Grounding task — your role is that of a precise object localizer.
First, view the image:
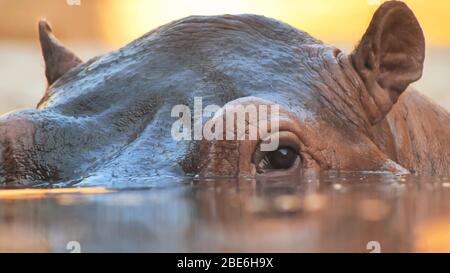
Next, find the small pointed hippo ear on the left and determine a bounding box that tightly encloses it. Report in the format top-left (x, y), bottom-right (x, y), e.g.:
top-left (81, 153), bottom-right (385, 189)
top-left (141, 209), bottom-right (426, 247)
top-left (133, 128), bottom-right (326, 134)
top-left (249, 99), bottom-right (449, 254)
top-left (39, 21), bottom-right (82, 85)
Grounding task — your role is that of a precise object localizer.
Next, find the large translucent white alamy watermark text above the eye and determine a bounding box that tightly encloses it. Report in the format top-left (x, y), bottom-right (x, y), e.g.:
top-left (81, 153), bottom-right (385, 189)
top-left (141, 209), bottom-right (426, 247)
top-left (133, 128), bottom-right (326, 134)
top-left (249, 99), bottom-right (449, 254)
top-left (171, 97), bottom-right (280, 151)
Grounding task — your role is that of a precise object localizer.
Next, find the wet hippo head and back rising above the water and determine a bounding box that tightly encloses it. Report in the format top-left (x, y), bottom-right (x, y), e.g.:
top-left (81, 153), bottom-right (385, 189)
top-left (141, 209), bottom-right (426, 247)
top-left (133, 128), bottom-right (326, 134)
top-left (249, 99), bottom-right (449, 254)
top-left (0, 1), bottom-right (450, 187)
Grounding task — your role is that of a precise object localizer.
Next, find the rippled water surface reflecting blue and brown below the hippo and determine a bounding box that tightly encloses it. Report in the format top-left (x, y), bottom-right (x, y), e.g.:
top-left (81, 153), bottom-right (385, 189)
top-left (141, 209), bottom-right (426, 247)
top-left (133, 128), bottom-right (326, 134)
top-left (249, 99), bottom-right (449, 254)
top-left (0, 173), bottom-right (450, 252)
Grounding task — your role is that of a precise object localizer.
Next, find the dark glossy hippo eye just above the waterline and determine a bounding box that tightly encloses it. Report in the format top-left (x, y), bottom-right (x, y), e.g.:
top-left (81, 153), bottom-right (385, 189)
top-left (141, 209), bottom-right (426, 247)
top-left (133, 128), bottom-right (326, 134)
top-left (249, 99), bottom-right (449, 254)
top-left (258, 147), bottom-right (301, 172)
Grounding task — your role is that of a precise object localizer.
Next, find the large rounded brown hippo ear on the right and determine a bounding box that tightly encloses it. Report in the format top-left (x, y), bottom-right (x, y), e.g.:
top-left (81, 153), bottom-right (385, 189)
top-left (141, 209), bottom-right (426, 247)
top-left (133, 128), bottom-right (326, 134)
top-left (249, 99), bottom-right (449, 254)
top-left (351, 1), bottom-right (425, 123)
